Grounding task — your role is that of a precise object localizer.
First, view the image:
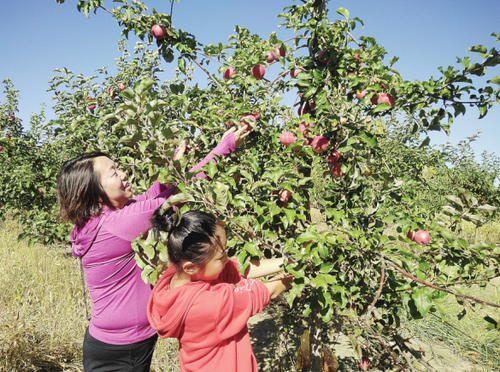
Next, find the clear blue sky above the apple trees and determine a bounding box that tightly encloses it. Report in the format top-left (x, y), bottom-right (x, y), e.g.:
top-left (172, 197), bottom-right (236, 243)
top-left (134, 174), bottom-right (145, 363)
top-left (0, 0), bottom-right (500, 160)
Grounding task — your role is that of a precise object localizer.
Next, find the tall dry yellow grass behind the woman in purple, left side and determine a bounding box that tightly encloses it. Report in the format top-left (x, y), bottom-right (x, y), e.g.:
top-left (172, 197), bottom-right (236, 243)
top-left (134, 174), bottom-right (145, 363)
top-left (0, 219), bottom-right (179, 372)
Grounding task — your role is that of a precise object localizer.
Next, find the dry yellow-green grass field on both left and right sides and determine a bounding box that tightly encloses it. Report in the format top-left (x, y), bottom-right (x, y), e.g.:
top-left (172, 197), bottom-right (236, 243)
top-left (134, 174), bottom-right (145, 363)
top-left (0, 220), bottom-right (500, 372)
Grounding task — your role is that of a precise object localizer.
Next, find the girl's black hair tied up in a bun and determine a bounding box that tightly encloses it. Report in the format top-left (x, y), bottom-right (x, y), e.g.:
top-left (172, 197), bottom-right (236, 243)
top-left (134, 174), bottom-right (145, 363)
top-left (151, 208), bottom-right (221, 269)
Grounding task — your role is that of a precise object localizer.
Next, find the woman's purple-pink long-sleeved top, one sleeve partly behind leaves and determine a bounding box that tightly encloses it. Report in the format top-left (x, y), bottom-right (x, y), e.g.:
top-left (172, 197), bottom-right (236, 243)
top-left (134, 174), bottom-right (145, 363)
top-left (71, 133), bottom-right (235, 345)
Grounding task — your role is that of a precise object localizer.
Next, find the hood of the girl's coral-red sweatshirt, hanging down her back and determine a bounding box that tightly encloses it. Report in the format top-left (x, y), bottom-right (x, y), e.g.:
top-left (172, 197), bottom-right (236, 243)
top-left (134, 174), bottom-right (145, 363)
top-left (147, 265), bottom-right (210, 338)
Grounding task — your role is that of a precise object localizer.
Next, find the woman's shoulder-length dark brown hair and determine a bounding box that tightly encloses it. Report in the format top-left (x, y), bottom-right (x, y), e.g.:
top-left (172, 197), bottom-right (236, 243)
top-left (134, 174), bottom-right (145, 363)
top-left (57, 152), bottom-right (111, 223)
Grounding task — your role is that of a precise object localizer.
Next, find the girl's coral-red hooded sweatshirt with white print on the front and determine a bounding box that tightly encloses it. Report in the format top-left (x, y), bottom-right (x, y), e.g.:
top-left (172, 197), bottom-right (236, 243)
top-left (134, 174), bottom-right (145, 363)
top-left (148, 260), bottom-right (270, 372)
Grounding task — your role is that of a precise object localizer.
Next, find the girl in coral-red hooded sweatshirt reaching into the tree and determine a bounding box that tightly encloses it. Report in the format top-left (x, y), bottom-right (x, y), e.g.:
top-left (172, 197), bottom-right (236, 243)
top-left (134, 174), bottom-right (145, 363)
top-left (148, 209), bottom-right (293, 372)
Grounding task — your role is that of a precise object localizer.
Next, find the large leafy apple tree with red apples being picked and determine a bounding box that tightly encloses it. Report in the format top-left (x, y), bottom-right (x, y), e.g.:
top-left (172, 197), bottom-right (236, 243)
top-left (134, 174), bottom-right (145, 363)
top-left (9, 0), bottom-right (500, 371)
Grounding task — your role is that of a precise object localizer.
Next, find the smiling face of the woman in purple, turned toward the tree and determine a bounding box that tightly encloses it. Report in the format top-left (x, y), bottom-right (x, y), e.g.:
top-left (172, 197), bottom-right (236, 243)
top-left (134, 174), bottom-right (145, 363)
top-left (94, 156), bottom-right (132, 209)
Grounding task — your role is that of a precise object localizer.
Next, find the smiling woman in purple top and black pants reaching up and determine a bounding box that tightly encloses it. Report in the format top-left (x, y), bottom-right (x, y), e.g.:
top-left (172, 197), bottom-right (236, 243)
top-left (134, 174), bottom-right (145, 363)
top-left (57, 126), bottom-right (249, 372)
